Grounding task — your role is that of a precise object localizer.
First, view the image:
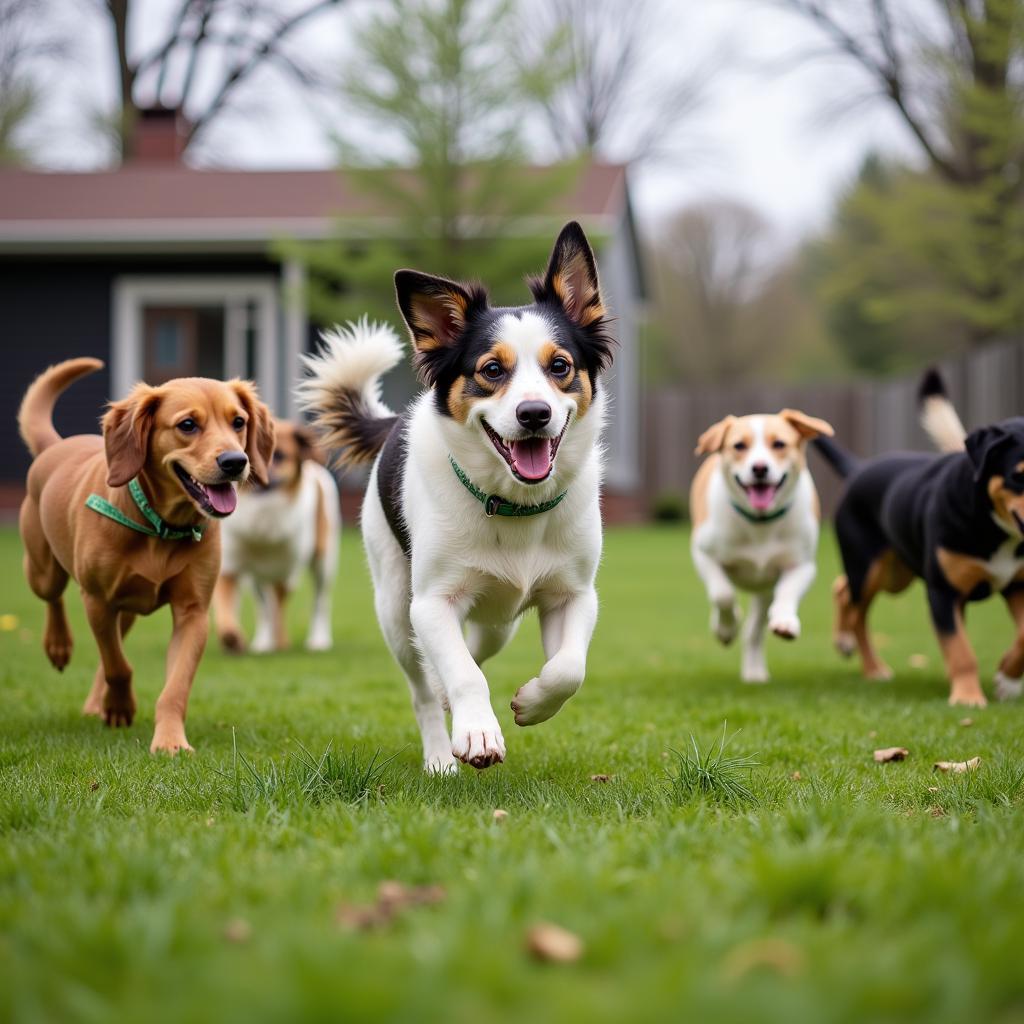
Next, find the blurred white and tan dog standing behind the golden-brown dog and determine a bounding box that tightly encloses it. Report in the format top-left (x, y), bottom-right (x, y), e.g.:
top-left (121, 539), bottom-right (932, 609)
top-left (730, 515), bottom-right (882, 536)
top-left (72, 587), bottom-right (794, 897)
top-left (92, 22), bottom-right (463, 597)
top-left (213, 420), bottom-right (341, 652)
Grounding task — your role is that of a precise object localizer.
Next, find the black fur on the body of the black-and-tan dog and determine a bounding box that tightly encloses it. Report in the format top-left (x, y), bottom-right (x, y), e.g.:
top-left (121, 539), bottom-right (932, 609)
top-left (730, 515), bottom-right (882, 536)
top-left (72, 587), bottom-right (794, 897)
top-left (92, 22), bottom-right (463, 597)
top-left (815, 419), bottom-right (1024, 634)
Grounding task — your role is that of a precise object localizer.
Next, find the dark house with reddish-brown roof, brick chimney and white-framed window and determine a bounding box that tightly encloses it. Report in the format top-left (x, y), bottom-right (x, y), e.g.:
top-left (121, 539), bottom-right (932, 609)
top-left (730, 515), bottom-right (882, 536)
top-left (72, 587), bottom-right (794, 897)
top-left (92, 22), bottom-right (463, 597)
top-left (0, 112), bottom-right (644, 518)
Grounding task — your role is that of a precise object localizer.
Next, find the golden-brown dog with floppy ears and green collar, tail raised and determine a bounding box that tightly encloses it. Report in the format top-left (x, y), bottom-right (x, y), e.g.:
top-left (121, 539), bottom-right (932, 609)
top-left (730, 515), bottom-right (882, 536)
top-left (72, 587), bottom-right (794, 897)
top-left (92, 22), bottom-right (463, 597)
top-left (18, 358), bottom-right (273, 754)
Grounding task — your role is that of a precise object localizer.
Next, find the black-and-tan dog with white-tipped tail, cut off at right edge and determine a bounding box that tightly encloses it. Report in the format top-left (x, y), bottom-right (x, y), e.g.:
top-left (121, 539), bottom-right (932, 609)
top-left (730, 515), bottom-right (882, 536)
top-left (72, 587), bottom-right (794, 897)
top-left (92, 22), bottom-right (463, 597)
top-left (813, 373), bottom-right (1024, 707)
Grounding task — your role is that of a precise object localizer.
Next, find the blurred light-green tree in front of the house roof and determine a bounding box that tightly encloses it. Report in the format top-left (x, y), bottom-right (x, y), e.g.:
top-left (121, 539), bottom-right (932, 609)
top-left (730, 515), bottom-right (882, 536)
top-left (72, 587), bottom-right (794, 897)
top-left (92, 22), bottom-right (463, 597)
top-left (285, 0), bottom-right (579, 323)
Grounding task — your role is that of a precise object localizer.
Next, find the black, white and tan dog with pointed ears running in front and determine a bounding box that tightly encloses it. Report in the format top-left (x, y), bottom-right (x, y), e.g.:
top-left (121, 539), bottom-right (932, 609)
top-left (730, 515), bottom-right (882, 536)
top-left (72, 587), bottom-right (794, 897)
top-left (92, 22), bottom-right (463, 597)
top-left (300, 223), bottom-right (613, 772)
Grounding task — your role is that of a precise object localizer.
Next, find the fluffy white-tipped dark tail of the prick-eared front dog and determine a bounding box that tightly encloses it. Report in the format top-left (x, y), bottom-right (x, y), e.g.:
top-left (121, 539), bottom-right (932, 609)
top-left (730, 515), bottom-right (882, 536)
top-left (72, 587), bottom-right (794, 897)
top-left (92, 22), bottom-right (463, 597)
top-left (297, 316), bottom-right (402, 465)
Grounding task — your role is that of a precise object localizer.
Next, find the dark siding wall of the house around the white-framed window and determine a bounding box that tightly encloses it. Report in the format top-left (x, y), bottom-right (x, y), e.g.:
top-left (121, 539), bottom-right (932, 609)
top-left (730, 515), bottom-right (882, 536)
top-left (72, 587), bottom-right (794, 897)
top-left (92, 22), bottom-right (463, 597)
top-left (0, 256), bottom-right (279, 487)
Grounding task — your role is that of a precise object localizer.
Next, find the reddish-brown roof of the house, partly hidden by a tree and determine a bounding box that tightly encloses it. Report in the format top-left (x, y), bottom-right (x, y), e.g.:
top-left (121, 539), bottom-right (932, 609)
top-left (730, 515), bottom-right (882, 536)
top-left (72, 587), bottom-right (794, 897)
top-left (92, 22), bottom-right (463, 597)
top-left (0, 164), bottom-right (626, 250)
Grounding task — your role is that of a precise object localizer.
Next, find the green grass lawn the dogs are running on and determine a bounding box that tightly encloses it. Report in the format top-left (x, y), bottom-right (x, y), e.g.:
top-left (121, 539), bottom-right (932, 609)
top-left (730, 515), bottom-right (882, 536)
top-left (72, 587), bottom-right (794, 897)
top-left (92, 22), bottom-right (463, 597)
top-left (0, 528), bottom-right (1024, 1024)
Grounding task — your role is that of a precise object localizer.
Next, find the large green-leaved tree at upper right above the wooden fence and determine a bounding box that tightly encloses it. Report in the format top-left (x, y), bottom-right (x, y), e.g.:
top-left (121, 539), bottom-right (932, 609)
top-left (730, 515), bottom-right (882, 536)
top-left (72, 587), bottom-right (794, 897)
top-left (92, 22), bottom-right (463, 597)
top-left (765, 0), bottom-right (1024, 350)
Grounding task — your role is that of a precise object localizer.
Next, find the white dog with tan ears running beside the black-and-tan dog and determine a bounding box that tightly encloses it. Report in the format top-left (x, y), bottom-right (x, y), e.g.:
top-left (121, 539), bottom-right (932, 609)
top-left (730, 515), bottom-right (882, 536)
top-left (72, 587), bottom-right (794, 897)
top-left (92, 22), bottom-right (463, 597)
top-left (690, 409), bottom-right (833, 683)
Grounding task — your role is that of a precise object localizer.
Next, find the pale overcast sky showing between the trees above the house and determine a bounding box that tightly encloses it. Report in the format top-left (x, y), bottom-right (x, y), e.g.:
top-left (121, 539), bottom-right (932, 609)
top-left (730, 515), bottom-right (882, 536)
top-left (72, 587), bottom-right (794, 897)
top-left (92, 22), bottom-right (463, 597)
top-left (36, 0), bottom-right (915, 242)
